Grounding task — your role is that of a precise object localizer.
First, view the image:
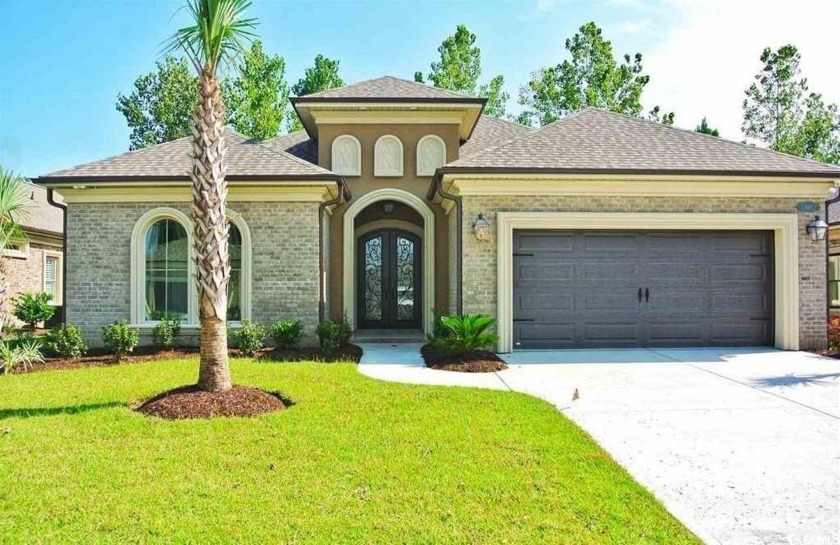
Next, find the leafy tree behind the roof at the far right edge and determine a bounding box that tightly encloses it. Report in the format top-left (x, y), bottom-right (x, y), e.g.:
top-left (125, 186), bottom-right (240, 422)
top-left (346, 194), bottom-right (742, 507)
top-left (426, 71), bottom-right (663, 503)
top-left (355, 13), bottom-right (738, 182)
top-left (741, 44), bottom-right (840, 163)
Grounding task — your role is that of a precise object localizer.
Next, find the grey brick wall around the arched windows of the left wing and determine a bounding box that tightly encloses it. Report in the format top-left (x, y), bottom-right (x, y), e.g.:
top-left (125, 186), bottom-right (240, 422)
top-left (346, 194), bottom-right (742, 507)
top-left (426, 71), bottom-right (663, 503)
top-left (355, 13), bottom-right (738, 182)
top-left (65, 202), bottom-right (319, 346)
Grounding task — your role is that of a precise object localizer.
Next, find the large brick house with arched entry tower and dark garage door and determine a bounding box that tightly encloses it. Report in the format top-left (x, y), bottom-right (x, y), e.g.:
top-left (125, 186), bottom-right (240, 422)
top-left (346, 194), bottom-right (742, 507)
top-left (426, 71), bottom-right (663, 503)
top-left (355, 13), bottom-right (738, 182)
top-left (38, 77), bottom-right (840, 352)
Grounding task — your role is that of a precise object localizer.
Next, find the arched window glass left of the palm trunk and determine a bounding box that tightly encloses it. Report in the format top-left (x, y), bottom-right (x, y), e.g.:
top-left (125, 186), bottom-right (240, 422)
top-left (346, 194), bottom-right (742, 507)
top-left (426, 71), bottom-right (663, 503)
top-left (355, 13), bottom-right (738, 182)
top-left (145, 219), bottom-right (190, 321)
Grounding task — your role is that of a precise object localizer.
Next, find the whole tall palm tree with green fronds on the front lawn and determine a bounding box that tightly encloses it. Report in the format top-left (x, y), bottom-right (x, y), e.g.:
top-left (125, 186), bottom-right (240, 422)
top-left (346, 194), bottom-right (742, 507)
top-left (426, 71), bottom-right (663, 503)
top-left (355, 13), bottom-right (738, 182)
top-left (166, 0), bottom-right (256, 392)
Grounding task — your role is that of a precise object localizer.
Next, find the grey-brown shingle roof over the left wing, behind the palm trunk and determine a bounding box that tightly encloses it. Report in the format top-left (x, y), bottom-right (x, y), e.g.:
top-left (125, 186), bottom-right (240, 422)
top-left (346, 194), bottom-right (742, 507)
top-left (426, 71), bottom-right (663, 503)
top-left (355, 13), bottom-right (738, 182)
top-left (39, 128), bottom-right (338, 182)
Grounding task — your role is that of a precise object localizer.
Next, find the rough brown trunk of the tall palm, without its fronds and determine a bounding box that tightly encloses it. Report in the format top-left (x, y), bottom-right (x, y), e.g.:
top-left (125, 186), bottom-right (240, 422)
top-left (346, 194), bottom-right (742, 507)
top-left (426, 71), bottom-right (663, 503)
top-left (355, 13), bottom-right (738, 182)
top-left (190, 70), bottom-right (231, 392)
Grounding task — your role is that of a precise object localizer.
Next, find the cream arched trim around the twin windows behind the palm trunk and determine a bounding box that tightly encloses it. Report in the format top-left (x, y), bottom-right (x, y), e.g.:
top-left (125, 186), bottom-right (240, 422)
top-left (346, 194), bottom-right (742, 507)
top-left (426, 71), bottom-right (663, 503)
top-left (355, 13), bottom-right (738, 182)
top-left (130, 207), bottom-right (251, 328)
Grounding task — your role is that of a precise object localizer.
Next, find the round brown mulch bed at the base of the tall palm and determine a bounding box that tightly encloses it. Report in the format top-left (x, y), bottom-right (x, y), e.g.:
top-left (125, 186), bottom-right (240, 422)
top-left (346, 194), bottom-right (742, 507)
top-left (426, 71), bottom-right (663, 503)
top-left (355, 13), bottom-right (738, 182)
top-left (137, 385), bottom-right (291, 420)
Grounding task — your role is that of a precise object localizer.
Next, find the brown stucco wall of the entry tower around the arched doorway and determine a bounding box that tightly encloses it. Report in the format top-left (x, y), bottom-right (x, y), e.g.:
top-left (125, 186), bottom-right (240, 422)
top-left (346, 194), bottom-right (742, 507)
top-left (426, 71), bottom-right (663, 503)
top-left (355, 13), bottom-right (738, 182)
top-left (318, 124), bottom-right (459, 321)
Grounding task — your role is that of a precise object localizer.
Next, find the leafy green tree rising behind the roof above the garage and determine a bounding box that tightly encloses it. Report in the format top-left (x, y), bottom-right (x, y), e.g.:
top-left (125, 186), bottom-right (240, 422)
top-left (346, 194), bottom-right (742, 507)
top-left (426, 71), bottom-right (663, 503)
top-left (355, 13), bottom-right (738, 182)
top-left (519, 22), bottom-right (673, 125)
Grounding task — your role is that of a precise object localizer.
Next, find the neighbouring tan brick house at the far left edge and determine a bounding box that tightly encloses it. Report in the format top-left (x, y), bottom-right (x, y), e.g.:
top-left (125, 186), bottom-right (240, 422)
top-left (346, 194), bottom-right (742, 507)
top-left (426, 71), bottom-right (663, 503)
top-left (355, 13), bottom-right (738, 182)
top-left (2, 182), bottom-right (64, 325)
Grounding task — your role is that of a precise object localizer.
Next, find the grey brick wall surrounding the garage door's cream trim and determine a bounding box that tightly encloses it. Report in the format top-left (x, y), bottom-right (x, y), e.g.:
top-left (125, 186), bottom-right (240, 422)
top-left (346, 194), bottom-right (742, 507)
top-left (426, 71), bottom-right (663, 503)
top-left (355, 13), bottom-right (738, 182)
top-left (461, 196), bottom-right (827, 350)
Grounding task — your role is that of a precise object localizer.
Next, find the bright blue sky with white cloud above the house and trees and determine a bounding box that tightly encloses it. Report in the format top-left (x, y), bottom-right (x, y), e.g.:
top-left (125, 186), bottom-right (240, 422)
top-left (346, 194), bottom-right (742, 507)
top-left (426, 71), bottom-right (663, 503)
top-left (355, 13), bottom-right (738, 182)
top-left (0, 0), bottom-right (840, 177)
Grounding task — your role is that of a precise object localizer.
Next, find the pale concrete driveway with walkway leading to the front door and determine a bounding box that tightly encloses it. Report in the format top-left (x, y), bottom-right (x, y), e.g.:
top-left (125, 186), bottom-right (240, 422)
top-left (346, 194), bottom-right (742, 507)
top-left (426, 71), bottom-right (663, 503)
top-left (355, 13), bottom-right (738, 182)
top-left (359, 345), bottom-right (840, 544)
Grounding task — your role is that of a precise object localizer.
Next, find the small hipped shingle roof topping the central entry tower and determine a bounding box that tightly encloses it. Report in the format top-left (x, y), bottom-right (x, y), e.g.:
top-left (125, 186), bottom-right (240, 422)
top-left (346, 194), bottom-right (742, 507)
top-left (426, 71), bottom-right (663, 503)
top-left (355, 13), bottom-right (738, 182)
top-left (292, 76), bottom-right (484, 102)
